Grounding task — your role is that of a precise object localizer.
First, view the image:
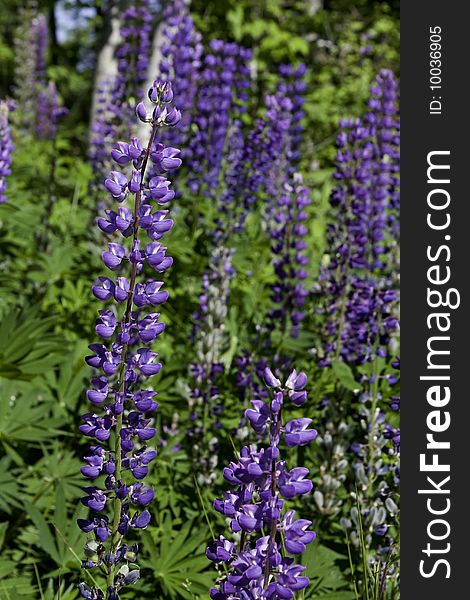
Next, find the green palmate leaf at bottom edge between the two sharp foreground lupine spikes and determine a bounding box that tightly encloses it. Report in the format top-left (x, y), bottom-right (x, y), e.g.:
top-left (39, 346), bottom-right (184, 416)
top-left (142, 519), bottom-right (213, 600)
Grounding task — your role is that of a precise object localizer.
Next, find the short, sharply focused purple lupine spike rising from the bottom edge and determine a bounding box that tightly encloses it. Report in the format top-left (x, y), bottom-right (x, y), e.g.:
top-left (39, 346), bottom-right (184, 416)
top-left (206, 368), bottom-right (317, 600)
